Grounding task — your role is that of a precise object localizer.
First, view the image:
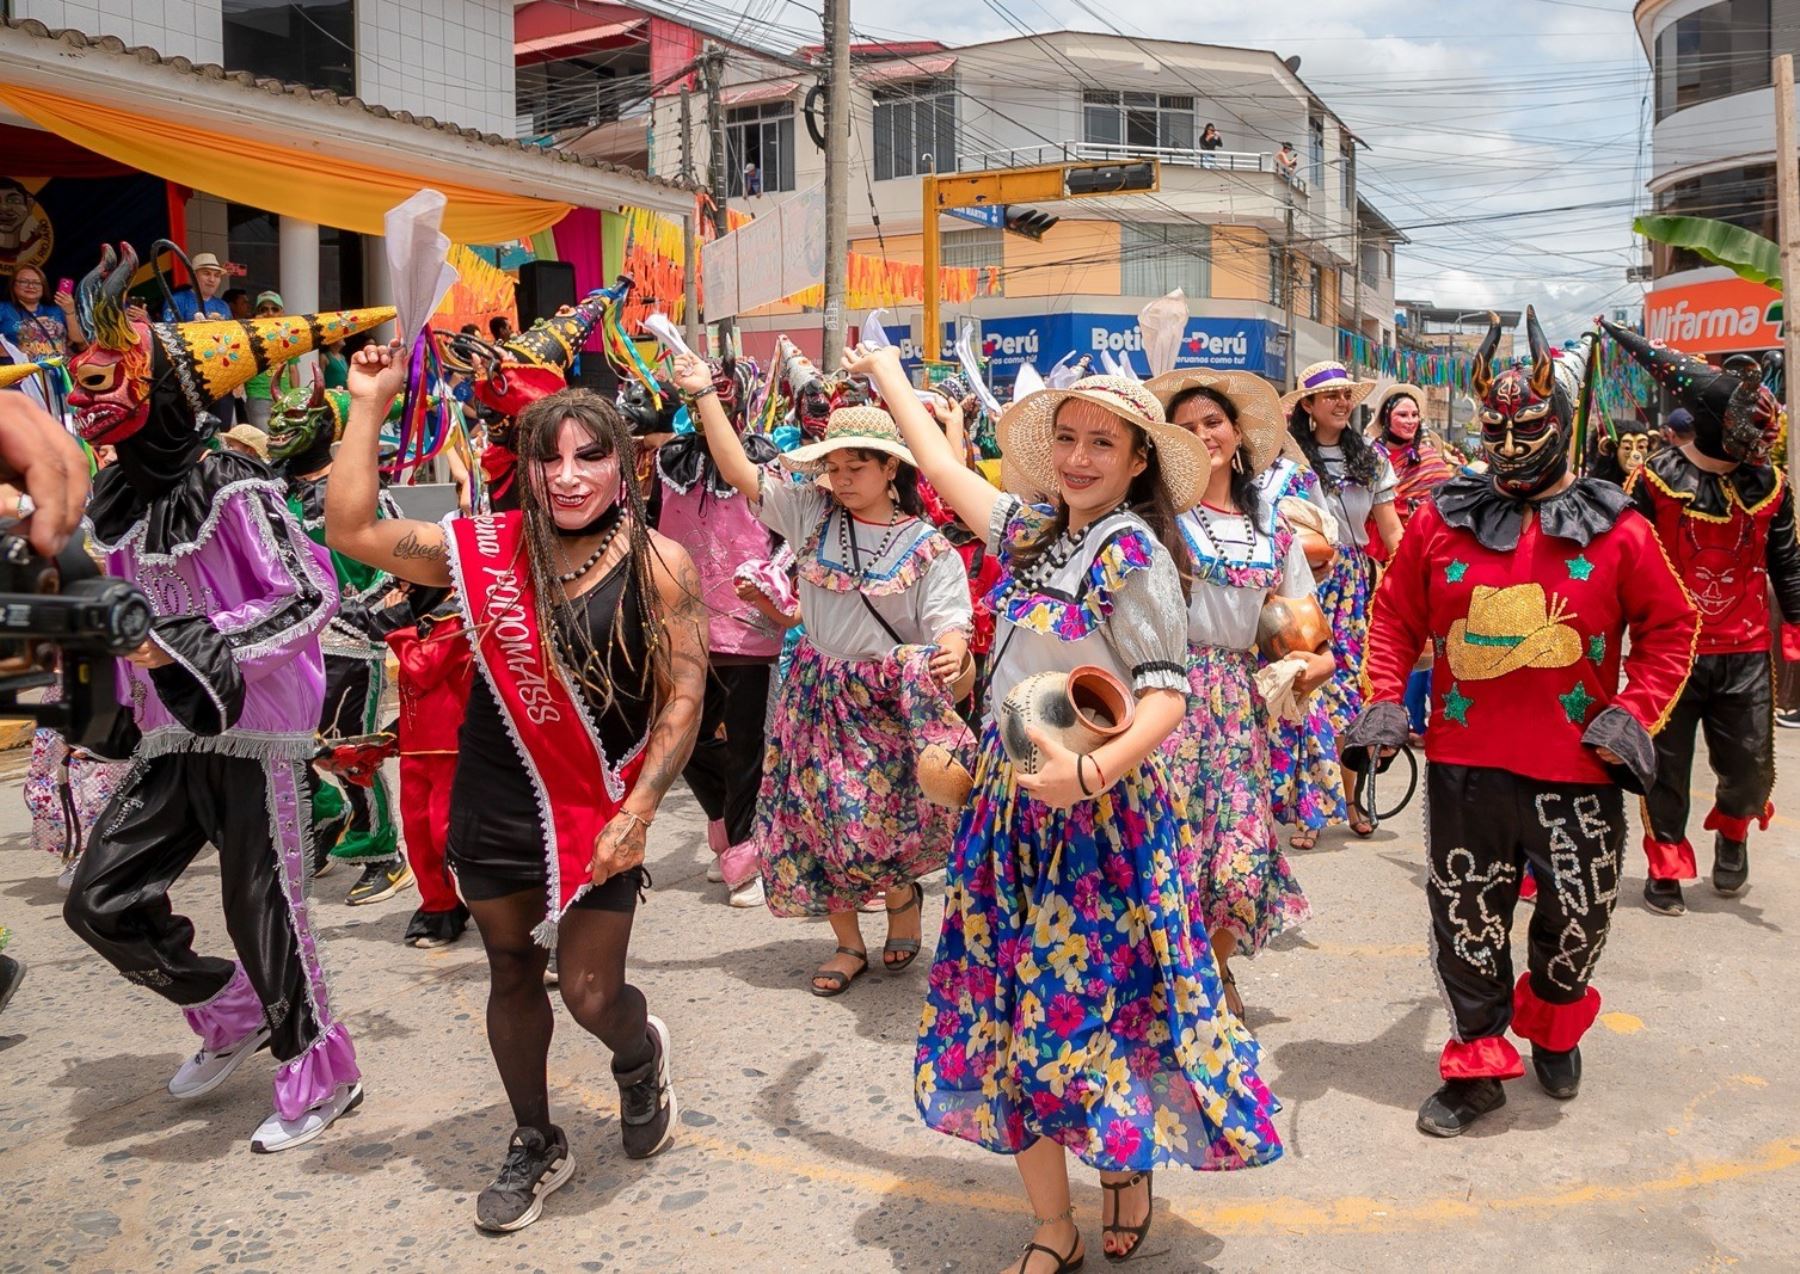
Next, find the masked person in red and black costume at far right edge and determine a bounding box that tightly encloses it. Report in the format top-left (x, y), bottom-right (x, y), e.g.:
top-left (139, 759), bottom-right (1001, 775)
top-left (1606, 324), bottom-right (1800, 914)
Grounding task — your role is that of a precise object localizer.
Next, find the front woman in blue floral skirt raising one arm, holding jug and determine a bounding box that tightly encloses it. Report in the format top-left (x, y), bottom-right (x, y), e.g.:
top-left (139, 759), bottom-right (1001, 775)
top-left (846, 347), bottom-right (1282, 1274)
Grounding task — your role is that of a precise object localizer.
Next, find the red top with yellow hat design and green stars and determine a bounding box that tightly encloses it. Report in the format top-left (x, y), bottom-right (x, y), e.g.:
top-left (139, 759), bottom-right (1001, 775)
top-left (1363, 502), bottom-right (1699, 785)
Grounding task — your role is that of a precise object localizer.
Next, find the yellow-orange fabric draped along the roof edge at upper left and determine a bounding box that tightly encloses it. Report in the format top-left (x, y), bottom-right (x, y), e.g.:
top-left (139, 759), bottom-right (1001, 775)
top-left (0, 85), bottom-right (572, 243)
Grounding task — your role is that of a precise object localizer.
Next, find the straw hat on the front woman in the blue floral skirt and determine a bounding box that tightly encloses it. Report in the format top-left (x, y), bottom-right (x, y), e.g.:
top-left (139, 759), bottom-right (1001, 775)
top-left (995, 376), bottom-right (1213, 513)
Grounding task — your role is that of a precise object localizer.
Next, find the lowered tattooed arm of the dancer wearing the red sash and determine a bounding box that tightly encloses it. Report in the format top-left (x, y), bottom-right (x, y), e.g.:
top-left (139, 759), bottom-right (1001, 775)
top-left (592, 531), bottom-right (707, 885)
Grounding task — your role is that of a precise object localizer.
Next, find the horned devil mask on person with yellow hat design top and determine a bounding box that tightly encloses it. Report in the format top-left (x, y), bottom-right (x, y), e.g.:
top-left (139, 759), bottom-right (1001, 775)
top-left (1472, 308), bottom-right (1573, 500)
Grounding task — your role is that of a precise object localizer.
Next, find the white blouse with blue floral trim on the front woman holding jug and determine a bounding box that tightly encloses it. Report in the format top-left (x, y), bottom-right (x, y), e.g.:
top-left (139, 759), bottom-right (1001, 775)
top-left (988, 493), bottom-right (1188, 711)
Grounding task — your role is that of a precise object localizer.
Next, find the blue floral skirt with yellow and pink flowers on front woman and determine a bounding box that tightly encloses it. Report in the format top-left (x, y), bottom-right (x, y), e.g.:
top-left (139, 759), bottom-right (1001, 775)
top-left (914, 725), bottom-right (1282, 1171)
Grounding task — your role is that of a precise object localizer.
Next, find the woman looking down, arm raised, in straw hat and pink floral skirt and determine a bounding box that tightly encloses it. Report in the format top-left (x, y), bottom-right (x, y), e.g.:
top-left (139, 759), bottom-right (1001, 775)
top-left (675, 356), bottom-right (974, 995)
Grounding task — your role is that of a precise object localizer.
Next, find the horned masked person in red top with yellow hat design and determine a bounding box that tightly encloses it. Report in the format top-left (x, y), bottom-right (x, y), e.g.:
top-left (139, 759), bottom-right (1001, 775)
top-left (1346, 315), bottom-right (1697, 1135)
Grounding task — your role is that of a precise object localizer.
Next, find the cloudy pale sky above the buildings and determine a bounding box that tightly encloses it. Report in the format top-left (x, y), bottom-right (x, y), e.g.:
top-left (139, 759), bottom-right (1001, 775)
top-left (795, 0), bottom-right (1651, 340)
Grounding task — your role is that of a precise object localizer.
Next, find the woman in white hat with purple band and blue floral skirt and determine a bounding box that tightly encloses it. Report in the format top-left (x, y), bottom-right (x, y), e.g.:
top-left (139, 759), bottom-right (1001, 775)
top-left (1282, 362), bottom-right (1400, 837)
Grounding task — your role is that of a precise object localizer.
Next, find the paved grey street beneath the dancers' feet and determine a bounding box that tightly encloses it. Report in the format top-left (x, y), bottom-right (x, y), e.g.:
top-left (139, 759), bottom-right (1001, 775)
top-left (0, 732), bottom-right (1800, 1274)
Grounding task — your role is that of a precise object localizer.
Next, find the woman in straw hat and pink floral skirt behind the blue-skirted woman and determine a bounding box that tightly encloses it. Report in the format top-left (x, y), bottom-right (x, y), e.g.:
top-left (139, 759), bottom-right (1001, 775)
top-left (1147, 371), bottom-right (1332, 1017)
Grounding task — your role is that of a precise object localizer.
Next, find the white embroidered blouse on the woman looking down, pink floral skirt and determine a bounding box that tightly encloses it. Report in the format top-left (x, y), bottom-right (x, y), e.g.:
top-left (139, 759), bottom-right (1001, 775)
top-left (756, 464), bottom-right (970, 660)
